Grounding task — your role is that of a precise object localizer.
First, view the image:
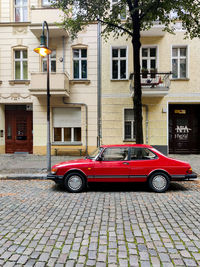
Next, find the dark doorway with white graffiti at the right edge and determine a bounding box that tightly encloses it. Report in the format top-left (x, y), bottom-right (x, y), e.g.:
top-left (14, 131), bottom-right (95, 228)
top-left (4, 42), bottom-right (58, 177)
top-left (169, 104), bottom-right (200, 154)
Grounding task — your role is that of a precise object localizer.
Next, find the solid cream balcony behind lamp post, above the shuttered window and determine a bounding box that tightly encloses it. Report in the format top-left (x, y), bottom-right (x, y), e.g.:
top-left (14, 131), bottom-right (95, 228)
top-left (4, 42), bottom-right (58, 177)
top-left (29, 72), bottom-right (70, 97)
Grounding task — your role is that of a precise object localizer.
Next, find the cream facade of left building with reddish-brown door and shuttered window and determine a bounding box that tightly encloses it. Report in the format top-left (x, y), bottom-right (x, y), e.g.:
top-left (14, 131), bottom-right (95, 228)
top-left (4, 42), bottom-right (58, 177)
top-left (0, 0), bottom-right (97, 154)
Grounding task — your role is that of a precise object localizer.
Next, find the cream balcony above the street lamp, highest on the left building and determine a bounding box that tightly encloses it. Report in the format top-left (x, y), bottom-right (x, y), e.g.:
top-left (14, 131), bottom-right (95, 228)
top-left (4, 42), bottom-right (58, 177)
top-left (30, 7), bottom-right (68, 38)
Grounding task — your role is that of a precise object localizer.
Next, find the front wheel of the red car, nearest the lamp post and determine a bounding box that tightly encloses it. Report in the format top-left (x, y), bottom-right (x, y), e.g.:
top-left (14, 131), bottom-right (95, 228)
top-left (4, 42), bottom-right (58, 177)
top-left (64, 172), bottom-right (86, 193)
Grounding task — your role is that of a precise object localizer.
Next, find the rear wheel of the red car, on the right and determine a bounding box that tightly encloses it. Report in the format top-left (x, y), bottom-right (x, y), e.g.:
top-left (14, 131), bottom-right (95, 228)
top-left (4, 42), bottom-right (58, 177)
top-left (148, 172), bottom-right (170, 193)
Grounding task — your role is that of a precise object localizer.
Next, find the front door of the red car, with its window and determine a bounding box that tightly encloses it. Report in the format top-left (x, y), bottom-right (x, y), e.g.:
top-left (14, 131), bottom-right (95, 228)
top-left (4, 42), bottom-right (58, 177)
top-left (94, 147), bottom-right (130, 182)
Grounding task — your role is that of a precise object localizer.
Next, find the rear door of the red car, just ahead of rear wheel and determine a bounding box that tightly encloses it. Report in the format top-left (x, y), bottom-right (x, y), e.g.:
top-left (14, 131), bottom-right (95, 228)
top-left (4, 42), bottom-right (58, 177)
top-left (129, 147), bottom-right (158, 182)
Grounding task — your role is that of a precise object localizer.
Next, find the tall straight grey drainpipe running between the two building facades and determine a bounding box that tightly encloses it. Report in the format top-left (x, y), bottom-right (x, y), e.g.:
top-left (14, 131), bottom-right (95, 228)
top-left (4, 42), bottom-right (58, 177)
top-left (97, 20), bottom-right (102, 147)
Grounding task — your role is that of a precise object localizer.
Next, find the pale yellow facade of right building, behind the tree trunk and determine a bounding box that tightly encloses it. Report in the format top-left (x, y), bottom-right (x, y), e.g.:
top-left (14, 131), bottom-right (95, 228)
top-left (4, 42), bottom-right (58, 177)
top-left (102, 21), bottom-right (200, 154)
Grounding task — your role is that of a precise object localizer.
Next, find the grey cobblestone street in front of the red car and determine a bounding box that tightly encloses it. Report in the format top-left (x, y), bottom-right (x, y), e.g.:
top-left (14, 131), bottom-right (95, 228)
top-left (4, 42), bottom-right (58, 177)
top-left (0, 180), bottom-right (200, 267)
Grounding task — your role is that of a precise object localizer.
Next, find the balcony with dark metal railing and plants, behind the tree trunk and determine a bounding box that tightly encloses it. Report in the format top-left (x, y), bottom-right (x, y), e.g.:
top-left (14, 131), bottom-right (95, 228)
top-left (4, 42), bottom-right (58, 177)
top-left (130, 72), bottom-right (172, 97)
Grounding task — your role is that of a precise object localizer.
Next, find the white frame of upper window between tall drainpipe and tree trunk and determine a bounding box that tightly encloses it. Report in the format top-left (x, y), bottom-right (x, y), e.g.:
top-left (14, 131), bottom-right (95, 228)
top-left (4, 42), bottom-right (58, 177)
top-left (111, 46), bottom-right (128, 81)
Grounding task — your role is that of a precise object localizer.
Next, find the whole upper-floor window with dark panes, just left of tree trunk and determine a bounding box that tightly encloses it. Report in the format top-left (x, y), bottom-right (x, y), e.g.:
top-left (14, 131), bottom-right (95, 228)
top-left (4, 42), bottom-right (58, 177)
top-left (112, 48), bottom-right (127, 80)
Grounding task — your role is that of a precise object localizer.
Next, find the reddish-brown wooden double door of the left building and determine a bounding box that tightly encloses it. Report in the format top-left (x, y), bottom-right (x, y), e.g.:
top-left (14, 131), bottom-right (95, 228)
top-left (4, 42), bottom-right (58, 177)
top-left (5, 105), bottom-right (33, 154)
